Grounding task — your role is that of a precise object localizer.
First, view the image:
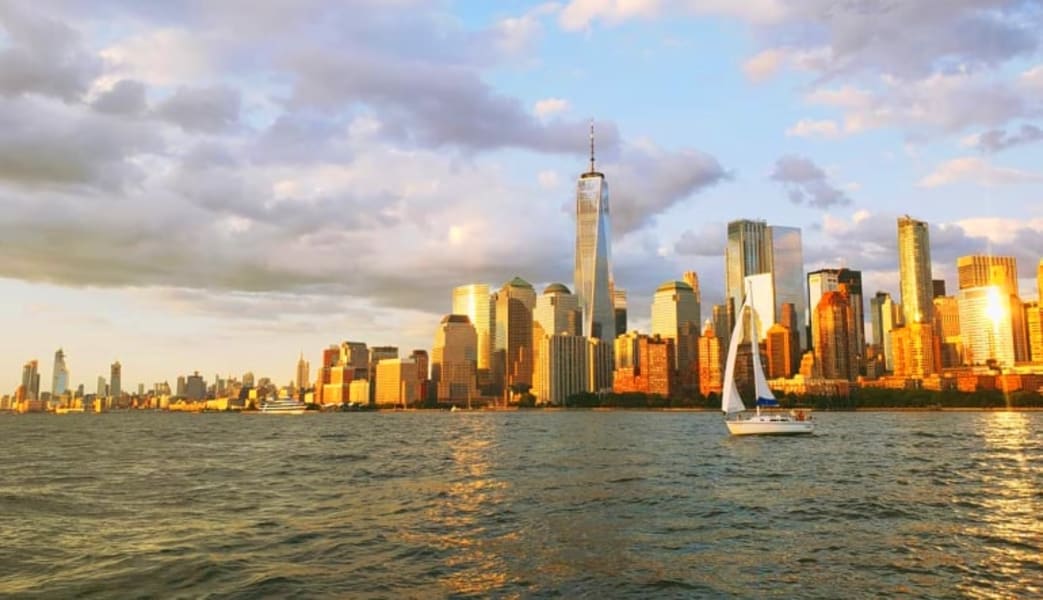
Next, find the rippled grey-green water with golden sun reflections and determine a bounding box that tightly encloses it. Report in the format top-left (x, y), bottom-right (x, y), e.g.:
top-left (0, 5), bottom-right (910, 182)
top-left (0, 411), bottom-right (1043, 598)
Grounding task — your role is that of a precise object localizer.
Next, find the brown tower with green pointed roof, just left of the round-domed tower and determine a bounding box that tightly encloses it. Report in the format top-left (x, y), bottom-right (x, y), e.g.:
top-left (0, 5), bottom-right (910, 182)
top-left (493, 278), bottom-right (534, 389)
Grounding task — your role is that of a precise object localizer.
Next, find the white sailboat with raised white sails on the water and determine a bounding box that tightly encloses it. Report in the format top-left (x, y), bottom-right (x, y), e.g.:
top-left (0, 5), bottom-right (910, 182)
top-left (721, 284), bottom-right (815, 435)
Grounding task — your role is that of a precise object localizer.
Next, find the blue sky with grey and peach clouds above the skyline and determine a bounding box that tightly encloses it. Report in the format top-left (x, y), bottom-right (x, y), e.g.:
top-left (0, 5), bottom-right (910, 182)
top-left (0, 0), bottom-right (1043, 393)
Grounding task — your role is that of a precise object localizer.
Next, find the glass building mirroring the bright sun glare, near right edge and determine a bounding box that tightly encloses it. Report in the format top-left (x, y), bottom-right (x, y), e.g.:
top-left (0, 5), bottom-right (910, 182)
top-left (959, 285), bottom-right (1015, 367)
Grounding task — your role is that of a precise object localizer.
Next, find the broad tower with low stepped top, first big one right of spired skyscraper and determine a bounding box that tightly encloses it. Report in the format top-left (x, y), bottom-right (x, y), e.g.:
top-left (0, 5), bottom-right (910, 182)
top-left (652, 282), bottom-right (700, 386)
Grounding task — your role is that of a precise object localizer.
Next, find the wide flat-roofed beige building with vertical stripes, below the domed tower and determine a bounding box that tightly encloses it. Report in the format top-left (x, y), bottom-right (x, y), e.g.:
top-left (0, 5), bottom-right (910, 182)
top-left (532, 327), bottom-right (602, 406)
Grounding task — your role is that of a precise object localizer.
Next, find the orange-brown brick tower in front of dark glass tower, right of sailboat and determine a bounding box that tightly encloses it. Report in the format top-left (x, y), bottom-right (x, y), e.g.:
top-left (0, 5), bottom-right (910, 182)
top-left (812, 284), bottom-right (858, 381)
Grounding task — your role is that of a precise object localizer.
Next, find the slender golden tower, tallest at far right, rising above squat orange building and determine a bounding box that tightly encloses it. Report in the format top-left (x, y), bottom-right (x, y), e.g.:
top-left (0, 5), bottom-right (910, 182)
top-left (898, 215), bottom-right (933, 326)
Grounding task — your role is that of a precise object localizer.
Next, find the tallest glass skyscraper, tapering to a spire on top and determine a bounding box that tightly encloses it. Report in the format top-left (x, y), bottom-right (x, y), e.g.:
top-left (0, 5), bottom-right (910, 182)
top-left (574, 121), bottom-right (615, 341)
